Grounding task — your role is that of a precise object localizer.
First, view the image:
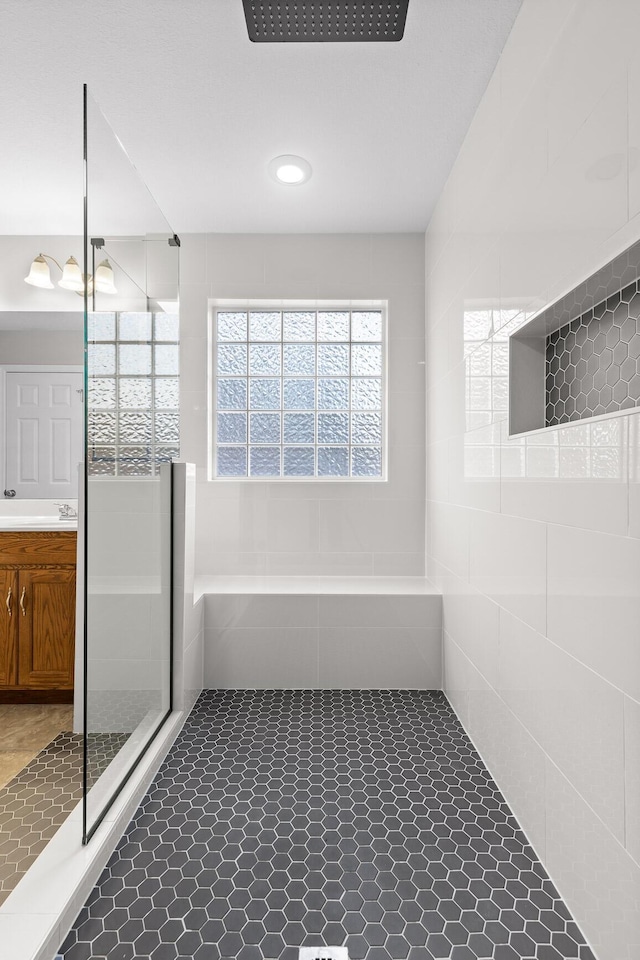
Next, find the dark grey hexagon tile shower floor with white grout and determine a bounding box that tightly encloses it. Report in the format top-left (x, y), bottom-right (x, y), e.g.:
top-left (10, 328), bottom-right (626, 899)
top-left (61, 690), bottom-right (593, 960)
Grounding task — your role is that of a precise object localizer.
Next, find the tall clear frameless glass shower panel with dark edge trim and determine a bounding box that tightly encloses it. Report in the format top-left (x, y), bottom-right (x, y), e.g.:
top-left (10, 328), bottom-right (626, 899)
top-left (82, 89), bottom-right (180, 841)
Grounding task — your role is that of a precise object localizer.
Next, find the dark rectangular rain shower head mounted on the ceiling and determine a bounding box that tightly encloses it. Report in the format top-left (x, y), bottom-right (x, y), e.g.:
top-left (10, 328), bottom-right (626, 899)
top-left (242, 0), bottom-right (409, 43)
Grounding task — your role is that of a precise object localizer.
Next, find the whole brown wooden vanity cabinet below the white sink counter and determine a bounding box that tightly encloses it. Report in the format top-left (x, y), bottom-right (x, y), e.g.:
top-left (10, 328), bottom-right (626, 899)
top-left (0, 531), bottom-right (76, 703)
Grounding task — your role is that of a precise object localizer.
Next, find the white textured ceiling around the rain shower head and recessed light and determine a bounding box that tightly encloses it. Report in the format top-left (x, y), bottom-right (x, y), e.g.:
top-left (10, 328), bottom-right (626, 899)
top-left (0, 0), bottom-right (521, 234)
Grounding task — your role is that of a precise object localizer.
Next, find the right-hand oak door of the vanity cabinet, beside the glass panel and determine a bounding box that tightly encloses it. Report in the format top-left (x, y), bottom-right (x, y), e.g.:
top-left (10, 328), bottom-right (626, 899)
top-left (17, 567), bottom-right (76, 690)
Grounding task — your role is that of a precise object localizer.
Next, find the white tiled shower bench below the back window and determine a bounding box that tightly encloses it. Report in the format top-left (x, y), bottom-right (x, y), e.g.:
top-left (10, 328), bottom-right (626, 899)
top-left (194, 576), bottom-right (442, 690)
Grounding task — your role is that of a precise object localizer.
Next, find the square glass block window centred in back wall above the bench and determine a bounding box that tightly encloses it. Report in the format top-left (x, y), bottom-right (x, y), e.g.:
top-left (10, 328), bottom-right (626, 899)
top-left (213, 307), bottom-right (385, 480)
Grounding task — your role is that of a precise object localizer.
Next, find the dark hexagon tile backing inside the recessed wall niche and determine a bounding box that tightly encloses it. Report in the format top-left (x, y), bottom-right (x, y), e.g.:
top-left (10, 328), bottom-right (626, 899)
top-left (545, 281), bottom-right (640, 427)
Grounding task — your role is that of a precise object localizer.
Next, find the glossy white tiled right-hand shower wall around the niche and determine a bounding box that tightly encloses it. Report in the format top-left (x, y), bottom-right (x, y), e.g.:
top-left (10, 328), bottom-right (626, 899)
top-left (425, 0), bottom-right (640, 960)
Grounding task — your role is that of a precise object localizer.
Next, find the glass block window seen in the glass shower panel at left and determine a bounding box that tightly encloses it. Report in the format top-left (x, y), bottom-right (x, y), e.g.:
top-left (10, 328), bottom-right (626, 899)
top-left (87, 313), bottom-right (180, 477)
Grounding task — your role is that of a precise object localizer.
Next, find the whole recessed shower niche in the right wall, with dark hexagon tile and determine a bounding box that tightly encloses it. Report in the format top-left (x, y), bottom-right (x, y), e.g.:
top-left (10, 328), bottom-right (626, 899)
top-left (509, 241), bottom-right (640, 436)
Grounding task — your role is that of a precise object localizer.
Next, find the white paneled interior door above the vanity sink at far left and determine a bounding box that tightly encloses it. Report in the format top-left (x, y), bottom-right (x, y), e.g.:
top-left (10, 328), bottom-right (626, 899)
top-left (5, 371), bottom-right (83, 500)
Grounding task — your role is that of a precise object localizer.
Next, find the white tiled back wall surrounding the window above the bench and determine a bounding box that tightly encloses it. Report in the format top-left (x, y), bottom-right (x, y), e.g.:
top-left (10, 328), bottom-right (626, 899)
top-left (180, 234), bottom-right (425, 576)
